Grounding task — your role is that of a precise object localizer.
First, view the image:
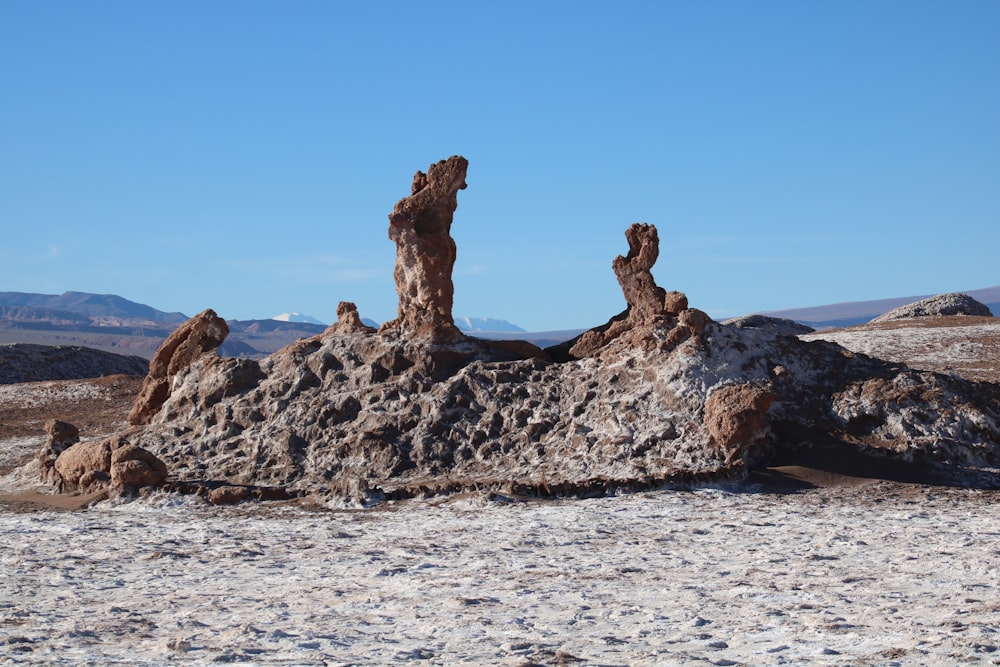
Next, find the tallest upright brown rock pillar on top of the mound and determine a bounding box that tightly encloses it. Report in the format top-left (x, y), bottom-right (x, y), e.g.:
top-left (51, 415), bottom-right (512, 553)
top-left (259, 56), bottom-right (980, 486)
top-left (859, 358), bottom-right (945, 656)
top-left (379, 155), bottom-right (469, 342)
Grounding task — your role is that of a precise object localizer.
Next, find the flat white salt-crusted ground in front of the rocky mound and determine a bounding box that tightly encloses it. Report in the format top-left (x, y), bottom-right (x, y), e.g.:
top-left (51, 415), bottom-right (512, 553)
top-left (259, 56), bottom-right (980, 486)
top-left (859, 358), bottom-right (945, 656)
top-left (0, 481), bottom-right (1000, 665)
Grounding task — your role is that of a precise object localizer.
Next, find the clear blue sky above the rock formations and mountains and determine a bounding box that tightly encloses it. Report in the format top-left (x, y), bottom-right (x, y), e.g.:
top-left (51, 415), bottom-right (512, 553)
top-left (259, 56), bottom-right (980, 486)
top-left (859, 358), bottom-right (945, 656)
top-left (0, 0), bottom-right (1000, 330)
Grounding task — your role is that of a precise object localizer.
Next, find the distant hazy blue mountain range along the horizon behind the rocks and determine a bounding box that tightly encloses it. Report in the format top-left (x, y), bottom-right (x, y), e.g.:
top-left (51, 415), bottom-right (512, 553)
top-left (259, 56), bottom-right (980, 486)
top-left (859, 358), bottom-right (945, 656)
top-left (0, 286), bottom-right (1000, 359)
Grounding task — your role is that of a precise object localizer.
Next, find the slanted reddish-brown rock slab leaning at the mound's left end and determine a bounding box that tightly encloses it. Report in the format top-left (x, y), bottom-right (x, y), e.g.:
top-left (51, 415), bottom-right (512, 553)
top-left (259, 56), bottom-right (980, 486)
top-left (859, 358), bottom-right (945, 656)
top-left (128, 308), bottom-right (229, 426)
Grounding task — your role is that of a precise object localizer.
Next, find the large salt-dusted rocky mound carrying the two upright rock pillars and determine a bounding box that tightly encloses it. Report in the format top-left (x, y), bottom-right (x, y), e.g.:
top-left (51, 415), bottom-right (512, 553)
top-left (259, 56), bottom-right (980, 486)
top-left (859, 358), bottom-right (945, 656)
top-left (41, 157), bottom-right (1000, 499)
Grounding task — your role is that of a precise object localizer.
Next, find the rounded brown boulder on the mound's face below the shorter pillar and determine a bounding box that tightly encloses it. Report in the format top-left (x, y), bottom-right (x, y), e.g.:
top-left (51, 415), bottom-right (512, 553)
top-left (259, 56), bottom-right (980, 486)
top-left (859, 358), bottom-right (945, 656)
top-left (705, 384), bottom-right (774, 464)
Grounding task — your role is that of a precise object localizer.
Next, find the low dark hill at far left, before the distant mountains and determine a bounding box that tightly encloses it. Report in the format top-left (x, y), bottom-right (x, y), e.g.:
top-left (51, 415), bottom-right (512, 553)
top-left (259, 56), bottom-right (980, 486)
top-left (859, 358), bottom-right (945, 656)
top-left (0, 343), bottom-right (149, 384)
